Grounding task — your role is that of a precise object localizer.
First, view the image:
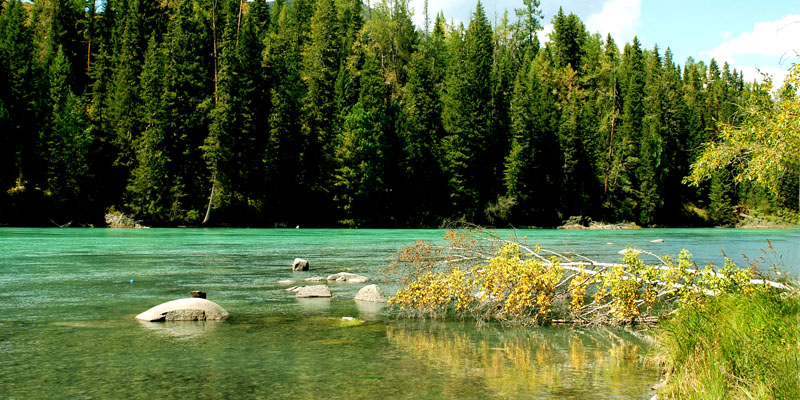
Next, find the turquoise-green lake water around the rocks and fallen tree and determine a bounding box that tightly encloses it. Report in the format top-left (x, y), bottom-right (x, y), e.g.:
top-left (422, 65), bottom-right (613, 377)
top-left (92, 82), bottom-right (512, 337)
top-left (0, 228), bottom-right (800, 399)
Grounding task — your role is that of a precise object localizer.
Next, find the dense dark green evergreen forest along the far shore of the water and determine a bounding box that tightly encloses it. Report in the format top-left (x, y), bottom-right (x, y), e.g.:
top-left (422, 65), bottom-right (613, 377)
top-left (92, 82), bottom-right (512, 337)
top-left (0, 0), bottom-right (797, 227)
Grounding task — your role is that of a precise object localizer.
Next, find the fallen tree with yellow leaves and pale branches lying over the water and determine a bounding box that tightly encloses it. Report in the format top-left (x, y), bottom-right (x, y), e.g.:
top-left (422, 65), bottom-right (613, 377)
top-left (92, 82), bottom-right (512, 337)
top-left (389, 228), bottom-right (788, 325)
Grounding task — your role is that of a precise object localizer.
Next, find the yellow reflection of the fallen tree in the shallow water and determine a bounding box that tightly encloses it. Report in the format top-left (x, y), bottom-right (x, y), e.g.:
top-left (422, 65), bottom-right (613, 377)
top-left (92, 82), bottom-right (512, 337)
top-left (387, 324), bottom-right (657, 398)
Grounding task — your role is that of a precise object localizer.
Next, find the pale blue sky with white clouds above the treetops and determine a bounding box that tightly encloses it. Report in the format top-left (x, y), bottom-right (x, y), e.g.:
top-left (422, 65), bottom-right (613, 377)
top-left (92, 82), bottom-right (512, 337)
top-left (410, 0), bottom-right (800, 87)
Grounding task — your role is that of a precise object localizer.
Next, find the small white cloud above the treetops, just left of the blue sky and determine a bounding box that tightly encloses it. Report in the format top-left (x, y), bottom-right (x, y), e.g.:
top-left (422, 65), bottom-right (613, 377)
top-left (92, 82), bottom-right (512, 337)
top-left (586, 0), bottom-right (642, 43)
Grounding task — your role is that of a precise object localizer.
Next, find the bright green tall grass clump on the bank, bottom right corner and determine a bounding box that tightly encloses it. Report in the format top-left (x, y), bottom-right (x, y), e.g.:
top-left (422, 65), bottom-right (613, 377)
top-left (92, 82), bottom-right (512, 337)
top-left (655, 288), bottom-right (800, 399)
